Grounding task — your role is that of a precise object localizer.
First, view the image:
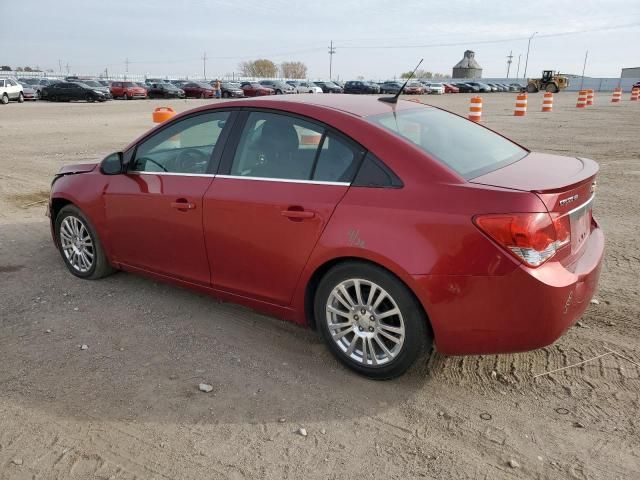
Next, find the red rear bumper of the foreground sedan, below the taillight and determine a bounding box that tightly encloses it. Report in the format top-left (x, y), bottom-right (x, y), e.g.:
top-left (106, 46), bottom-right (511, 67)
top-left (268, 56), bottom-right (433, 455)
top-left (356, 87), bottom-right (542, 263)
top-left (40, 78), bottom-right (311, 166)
top-left (414, 224), bottom-right (604, 355)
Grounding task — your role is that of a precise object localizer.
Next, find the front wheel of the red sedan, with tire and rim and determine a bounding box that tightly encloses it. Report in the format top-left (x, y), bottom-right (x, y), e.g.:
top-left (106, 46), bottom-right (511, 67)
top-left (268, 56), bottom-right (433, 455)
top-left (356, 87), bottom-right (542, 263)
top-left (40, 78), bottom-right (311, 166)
top-left (55, 205), bottom-right (115, 280)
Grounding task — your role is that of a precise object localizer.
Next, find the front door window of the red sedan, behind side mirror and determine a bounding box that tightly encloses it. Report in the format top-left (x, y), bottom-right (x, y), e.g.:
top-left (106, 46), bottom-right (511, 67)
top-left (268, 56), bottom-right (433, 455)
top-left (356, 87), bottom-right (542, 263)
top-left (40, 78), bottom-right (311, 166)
top-left (130, 112), bottom-right (229, 174)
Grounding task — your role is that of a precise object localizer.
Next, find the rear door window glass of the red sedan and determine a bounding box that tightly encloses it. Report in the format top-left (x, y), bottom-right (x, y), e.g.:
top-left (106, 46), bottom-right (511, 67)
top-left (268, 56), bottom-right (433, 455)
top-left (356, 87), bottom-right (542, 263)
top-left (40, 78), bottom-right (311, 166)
top-left (230, 112), bottom-right (361, 182)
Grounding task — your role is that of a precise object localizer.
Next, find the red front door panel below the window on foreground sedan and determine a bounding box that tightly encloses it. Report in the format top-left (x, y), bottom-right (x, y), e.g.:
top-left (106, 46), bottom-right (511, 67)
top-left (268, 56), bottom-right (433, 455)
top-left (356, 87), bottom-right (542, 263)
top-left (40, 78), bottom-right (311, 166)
top-left (103, 174), bottom-right (213, 285)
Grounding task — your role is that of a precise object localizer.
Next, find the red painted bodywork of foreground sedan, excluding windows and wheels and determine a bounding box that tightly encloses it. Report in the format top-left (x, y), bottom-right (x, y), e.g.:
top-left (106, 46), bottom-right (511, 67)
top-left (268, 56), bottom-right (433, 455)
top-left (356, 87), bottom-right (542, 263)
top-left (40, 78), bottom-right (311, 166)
top-left (52, 95), bottom-right (604, 354)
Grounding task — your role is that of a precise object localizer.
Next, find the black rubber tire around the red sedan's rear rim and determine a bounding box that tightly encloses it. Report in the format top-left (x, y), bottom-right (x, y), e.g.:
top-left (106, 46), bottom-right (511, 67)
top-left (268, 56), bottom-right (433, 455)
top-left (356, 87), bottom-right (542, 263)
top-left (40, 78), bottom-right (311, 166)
top-left (314, 261), bottom-right (433, 380)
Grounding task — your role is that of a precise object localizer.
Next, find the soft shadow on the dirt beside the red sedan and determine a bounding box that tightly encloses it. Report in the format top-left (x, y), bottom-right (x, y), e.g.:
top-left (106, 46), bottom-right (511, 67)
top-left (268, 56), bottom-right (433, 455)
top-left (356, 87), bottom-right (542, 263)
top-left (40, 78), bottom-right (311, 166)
top-left (0, 222), bottom-right (430, 423)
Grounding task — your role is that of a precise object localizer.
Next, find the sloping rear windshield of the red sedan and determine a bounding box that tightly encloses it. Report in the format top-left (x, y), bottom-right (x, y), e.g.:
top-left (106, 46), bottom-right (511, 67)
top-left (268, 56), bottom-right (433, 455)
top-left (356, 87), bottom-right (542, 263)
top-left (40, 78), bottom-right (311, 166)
top-left (368, 107), bottom-right (528, 180)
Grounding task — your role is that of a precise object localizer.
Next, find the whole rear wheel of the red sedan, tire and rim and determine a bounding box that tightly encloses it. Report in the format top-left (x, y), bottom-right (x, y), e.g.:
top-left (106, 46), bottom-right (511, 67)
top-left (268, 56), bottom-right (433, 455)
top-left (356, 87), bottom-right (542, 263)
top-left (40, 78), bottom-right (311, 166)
top-left (314, 262), bottom-right (433, 380)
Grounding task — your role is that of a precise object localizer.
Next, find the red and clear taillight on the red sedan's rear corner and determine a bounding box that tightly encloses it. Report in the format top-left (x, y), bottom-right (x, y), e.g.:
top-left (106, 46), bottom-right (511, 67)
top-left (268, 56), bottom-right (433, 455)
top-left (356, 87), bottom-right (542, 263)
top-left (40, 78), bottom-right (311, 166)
top-left (473, 213), bottom-right (571, 267)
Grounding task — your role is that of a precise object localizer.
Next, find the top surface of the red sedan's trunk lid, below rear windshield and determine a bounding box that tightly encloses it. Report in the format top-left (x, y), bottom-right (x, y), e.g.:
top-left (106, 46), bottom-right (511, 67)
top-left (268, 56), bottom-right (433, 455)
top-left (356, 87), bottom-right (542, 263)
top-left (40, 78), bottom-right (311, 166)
top-left (469, 152), bottom-right (599, 192)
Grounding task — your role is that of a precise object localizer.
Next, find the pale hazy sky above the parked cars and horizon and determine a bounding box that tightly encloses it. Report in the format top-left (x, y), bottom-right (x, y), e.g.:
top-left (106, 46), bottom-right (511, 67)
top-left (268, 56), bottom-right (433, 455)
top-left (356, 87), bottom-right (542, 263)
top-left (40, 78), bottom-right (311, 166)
top-left (0, 0), bottom-right (640, 80)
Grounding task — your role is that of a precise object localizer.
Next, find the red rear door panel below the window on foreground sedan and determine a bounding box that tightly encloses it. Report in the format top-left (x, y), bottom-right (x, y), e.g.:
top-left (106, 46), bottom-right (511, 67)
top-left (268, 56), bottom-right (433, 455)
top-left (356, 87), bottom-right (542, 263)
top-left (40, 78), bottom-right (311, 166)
top-left (203, 178), bottom-right (348, 306)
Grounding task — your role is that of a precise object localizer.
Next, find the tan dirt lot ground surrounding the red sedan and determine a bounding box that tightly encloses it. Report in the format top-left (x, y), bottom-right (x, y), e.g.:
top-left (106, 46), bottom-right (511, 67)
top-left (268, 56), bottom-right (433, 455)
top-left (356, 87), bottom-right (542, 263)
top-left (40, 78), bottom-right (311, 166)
top-left (0, 93), bottom-right (640, 480)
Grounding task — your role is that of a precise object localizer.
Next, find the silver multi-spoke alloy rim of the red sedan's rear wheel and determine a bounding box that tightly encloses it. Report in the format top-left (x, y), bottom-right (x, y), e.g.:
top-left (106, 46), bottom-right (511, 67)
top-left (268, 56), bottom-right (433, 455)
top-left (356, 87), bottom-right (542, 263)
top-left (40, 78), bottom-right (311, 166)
top-left (325, 278), bottom-right (405, 367)
